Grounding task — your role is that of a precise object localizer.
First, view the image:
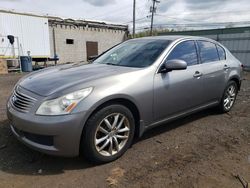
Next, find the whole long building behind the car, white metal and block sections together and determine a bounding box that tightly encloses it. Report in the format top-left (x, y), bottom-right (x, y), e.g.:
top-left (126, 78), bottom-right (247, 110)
top-left (0, 10), bottom-right (128, 63)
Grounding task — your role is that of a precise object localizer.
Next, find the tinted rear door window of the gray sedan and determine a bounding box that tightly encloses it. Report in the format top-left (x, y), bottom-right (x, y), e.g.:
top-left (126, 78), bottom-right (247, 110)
top-left (198, 41), bottom-right (219, 63)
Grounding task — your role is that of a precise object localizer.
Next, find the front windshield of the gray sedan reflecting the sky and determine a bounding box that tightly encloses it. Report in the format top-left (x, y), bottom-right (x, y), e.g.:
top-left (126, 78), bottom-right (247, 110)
top-left (94, 39), bottom-right (171, 67)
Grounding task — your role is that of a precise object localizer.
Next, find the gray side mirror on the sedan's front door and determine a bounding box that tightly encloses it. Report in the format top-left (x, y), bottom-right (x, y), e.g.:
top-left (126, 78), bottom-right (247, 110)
top-left (161, 59), bottom-right (187, 72)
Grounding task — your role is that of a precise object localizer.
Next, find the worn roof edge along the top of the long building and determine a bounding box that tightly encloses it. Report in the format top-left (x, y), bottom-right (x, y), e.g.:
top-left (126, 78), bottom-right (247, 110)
top-left (0, 9), bottom-right (128, 31)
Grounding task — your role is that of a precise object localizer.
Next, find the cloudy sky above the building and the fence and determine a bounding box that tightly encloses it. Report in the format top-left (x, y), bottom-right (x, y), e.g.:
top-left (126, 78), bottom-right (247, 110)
top-left (0, 0), bottom-right (250, 31)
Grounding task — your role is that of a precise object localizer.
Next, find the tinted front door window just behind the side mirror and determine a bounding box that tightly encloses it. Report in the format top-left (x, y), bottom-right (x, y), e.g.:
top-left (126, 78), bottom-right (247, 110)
top-left (167, 41), bottom-right (198, 66)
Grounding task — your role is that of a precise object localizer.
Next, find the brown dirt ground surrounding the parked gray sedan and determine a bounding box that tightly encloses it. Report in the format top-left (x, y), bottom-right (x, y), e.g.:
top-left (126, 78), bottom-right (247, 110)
top-left (0, 73), bottom-right (250, 188)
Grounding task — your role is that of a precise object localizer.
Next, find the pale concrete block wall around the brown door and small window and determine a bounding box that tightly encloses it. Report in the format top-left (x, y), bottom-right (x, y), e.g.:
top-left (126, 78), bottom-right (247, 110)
top-left (49, 25), bottom-right (126, 63)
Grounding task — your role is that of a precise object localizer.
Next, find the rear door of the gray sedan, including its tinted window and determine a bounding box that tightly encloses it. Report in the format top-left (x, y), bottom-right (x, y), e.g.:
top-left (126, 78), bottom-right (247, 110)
top-left (197, 40), bottom-right (227, 103)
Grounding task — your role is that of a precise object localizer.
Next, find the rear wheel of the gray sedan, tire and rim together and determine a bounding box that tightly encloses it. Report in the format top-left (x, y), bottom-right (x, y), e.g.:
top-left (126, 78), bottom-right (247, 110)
top-left (219, 80), bottom-right (238, 113)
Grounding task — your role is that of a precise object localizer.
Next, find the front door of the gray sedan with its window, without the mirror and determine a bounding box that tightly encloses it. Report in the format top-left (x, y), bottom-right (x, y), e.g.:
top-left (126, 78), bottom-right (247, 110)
top-left (154, 40), bottom-right (203, 121)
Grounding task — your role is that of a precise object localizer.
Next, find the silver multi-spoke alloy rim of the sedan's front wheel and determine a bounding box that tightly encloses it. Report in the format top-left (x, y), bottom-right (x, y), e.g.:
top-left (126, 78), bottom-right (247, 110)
top-left (95, 113), bottom-right (130, 156)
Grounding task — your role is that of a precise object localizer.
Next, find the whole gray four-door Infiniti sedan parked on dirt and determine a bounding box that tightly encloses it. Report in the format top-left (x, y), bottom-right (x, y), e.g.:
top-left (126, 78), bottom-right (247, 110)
top-left (7, 36), bottom-right (242, 163)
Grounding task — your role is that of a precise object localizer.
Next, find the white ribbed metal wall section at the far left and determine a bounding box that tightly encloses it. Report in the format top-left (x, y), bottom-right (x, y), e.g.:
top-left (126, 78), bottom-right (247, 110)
top-left (0, 10), bottom-right (50, 58)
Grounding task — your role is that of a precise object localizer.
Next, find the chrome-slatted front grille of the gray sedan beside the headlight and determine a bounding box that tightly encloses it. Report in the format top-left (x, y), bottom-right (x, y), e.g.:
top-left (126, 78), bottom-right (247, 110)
top-left (10, 88), bottom-right (36, 112)
